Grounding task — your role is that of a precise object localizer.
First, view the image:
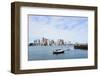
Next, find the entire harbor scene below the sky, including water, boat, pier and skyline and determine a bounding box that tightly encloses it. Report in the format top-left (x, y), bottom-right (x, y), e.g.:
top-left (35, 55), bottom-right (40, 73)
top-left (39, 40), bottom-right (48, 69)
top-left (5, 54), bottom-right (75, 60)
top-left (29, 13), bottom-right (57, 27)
top-left (28, 38), bottom-right (88, 61)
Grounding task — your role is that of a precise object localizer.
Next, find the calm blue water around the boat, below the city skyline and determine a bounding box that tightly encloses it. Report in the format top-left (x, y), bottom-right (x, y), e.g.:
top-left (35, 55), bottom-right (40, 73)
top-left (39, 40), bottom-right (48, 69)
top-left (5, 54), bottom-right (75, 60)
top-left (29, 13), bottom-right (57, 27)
top-left (28, 46), bottom-right (88, 60)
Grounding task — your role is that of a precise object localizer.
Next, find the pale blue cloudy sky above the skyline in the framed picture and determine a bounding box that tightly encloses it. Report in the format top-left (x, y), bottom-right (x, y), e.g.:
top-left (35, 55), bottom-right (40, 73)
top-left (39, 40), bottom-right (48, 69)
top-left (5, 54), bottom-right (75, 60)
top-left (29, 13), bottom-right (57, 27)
top-left (28, 15), bottom-right (88, 43)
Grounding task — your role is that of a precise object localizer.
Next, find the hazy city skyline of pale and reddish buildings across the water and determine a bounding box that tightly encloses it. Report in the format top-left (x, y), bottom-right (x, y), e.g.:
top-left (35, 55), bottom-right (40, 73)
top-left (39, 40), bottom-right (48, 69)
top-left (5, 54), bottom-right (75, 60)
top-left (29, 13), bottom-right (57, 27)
top-left (32, 38), bottom-right (66, 46)
